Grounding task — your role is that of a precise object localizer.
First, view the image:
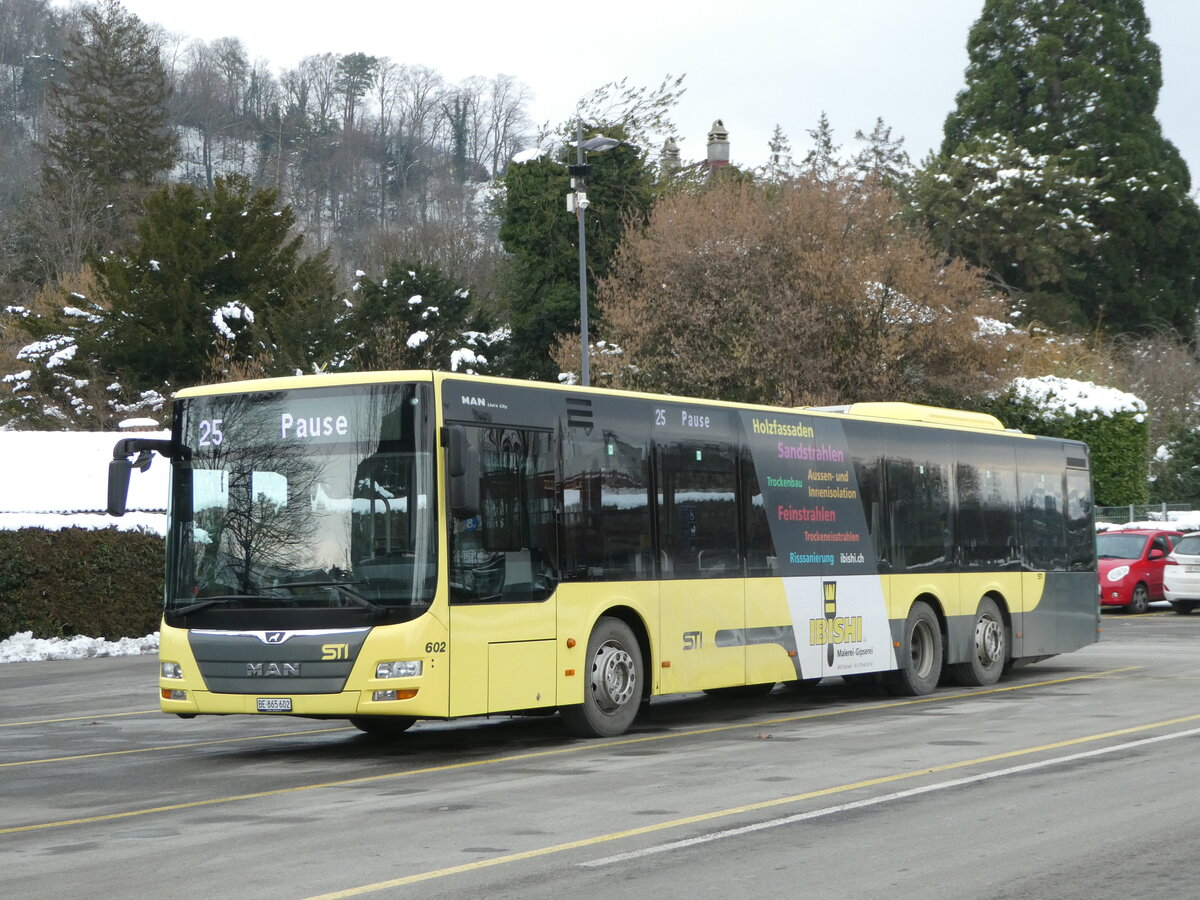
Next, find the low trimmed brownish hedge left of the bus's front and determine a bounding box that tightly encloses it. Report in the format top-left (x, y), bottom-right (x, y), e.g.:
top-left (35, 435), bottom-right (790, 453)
top-left (0, 528), bottom-right (164, 641)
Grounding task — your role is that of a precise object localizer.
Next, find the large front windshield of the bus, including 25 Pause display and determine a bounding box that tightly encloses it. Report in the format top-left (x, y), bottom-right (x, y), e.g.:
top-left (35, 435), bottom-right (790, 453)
top-left (167, 384), bottom-right (437, 619)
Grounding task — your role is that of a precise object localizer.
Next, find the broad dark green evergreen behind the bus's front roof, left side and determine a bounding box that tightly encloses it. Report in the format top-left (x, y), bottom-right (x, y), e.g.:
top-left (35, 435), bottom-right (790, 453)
top-left (90, 175), bottom-right (344, 389)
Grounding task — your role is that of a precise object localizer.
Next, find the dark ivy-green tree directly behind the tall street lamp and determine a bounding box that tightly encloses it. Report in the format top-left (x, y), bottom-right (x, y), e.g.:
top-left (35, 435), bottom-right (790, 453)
top-left (498, 125), bottom-right (654, 380)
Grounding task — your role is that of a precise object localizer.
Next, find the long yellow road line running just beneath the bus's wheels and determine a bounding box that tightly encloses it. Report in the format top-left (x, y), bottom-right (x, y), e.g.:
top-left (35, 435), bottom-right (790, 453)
top-left (0, 666), bottom-right (1141, 834)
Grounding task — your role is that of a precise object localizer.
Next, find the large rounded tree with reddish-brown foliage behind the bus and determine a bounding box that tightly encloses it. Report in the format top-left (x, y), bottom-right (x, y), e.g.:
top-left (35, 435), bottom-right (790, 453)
top-left (557, 178), bottom-right (1016, 406)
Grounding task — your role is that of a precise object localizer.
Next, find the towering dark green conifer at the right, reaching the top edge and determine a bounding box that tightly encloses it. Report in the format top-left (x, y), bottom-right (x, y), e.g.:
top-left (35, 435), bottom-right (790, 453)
top-left (917, 0), bottom-right (1200, 332)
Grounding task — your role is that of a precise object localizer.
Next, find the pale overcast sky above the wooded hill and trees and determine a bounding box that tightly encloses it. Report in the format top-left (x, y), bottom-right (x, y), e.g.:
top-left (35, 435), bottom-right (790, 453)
top-left (108, 0), bottom-right (1200, 182)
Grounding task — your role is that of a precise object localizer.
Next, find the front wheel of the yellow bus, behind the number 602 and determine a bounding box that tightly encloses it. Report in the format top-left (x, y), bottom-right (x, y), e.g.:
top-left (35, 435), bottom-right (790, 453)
top-left (560, 617), bottom-right (646, 738)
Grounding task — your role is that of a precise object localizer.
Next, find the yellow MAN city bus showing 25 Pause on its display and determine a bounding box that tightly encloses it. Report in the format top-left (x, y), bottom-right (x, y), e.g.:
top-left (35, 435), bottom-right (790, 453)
top-left (109, 372), bottom-right (1099, 736)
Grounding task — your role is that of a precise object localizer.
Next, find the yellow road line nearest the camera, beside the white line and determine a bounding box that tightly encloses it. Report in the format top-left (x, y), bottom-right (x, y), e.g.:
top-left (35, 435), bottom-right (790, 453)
top-left (308, 713), bottom-right (1200, 900)
